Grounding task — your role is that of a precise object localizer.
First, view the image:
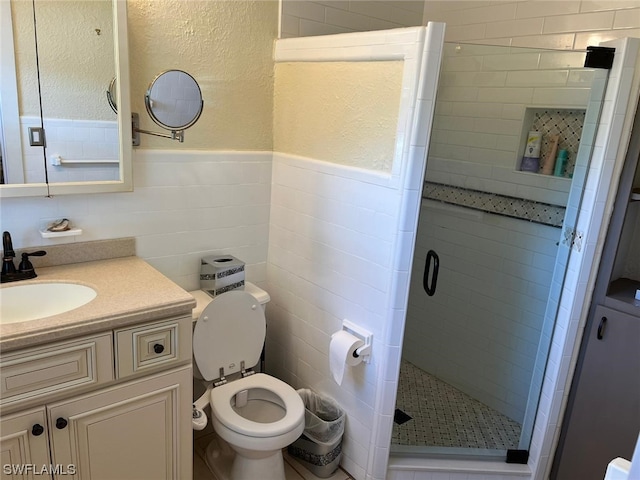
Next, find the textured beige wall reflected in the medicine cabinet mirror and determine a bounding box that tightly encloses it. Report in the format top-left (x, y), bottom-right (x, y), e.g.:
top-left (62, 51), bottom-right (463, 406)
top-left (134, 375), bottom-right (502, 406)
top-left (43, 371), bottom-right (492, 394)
top-left (11, 0), bottom-right (115, 120)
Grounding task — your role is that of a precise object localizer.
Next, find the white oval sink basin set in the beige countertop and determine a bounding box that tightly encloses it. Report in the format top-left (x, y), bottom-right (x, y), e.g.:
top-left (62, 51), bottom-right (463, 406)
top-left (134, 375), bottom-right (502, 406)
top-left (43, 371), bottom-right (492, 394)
top-left (0, 283), bottom-right (97, 324)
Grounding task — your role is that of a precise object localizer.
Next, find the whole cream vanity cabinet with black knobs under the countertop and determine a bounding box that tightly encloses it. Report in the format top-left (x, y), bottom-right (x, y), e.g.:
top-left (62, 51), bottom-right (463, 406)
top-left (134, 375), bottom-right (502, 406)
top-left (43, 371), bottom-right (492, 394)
top-left (0, 316), bottom-right (192, 480)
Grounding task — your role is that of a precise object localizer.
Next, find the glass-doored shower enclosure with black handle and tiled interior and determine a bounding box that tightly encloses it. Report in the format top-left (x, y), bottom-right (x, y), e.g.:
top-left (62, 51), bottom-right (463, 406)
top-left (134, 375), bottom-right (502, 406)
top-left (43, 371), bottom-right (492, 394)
top-left (391, 43), bottom-right (607, 463)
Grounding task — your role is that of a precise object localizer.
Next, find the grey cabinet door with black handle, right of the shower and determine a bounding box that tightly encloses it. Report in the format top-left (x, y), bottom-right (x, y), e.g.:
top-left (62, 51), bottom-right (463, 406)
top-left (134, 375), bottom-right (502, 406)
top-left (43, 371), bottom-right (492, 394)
top-left (553, 306), bottom-right (640, 480)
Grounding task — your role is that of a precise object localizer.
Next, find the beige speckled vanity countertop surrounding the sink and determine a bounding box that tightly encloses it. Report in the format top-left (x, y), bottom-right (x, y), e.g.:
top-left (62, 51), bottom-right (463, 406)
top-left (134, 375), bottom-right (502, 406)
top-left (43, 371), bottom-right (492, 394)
top-left (0, 256), bottom-right (196, 351)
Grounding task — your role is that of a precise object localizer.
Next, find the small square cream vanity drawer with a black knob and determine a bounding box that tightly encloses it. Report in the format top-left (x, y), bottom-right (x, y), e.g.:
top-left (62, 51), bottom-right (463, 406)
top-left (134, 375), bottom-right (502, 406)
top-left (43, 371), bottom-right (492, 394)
top-left (115, 317), bottom-right (191, 378)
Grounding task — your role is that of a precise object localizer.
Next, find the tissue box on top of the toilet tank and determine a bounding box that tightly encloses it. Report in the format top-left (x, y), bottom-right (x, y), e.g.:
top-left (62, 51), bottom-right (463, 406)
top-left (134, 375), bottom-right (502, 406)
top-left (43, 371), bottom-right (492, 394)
top-left (200, 255), bottom-right (244, 297)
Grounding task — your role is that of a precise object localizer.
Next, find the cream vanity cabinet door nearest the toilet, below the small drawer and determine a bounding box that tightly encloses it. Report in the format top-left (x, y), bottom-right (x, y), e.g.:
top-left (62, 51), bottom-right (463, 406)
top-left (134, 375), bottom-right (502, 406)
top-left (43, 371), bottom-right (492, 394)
top-left (47, 367), bottom-right (192, 480)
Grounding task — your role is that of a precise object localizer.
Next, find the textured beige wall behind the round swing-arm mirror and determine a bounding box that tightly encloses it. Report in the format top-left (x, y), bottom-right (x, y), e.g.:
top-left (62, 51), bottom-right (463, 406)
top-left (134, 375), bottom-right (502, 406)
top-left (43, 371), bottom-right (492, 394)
top-left (127, 0), bottom-right (278, 150)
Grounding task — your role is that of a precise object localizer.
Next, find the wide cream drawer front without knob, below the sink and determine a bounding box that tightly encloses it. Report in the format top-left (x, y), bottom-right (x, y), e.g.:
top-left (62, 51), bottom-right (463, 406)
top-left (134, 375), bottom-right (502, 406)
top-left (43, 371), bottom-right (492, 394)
top-left (0, 332), bottom-right (113, 407)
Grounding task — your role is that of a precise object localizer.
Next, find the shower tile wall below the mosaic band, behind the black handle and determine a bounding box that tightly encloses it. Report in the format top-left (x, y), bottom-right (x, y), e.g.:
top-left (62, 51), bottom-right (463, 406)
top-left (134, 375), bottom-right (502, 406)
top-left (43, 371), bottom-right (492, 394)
top-left (403, 201), bottom-right (560, 423)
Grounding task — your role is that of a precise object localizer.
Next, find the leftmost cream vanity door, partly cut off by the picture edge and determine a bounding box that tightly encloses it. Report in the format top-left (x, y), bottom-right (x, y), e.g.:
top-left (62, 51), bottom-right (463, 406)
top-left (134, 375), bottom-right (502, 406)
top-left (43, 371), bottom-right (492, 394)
top-left (0, 407), bottom-right (51, 479)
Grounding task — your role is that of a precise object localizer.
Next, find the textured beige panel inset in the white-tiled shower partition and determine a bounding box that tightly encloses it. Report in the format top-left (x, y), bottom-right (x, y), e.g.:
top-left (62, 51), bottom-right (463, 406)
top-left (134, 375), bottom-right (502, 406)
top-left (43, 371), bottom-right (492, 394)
top-left (273, 61), bottom-right (403, 172)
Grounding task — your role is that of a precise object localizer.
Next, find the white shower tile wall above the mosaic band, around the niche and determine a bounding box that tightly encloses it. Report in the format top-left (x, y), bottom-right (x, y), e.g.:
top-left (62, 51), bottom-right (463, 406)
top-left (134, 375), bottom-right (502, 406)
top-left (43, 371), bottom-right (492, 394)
top-left (427, 44), bottom-right (593, 206)
